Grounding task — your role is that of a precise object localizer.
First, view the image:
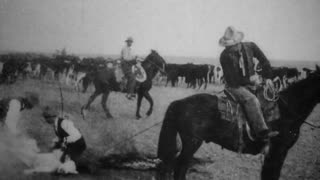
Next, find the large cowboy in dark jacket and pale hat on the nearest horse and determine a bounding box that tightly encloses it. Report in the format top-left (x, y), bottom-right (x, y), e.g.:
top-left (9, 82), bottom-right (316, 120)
top-left (219, 27), bottom-right (278, 140)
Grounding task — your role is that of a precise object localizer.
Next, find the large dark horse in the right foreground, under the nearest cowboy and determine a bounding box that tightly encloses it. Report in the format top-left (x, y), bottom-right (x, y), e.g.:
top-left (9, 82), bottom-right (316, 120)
top-left (158, 66), bottom-right (320, 180)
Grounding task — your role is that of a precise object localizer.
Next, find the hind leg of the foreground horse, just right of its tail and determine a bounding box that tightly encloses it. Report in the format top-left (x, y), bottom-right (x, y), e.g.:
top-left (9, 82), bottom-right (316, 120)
top-left (174, 136), bottom-right (202, 180)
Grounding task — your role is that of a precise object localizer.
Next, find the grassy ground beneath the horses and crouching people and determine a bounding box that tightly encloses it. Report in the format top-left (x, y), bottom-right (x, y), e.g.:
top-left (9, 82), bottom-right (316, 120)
top-left (0, 80), bottom-right (320, 180)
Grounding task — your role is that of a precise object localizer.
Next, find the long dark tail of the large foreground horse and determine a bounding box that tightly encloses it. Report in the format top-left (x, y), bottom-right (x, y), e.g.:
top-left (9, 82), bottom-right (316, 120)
top-left (158, 102), bottom-right (178, 162)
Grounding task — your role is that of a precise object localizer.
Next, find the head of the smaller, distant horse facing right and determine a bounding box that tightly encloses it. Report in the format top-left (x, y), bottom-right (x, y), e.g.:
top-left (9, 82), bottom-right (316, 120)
top-left (144, 50), bottom-right (166, 72)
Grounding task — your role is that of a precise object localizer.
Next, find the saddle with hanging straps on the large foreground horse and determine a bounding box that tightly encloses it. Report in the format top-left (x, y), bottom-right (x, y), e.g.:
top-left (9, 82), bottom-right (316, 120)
top-left (218, 88), bottom-right (280, 153)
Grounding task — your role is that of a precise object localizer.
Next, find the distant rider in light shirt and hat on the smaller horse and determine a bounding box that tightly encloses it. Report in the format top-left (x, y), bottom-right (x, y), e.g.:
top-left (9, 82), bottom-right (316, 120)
top-left (120, 37), bottom-right (137, 100)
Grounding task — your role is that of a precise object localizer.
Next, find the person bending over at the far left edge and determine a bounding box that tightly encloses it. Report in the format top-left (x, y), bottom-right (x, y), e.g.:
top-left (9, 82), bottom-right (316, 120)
top-left (0, 92), bottom-right (39, 135)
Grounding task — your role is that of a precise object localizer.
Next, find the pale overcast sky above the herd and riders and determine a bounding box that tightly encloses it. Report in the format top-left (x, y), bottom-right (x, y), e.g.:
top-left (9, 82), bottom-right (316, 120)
top-left (0, 0), bottom-right (320, 60)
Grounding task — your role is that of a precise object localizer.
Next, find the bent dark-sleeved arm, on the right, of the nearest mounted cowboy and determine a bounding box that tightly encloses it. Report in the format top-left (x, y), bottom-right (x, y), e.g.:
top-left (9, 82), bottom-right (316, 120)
top-left (251, 42), bottom-right (272, 79)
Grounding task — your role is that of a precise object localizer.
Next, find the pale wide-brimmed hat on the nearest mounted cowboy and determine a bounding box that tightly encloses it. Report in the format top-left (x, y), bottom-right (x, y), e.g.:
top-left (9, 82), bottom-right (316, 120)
top-left (219, 26), bottom-right (244, 47)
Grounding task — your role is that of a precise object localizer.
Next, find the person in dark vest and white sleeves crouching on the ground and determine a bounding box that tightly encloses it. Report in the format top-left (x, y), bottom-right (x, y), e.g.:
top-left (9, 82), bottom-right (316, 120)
top-left (43, 107), bottom-right (86, 169)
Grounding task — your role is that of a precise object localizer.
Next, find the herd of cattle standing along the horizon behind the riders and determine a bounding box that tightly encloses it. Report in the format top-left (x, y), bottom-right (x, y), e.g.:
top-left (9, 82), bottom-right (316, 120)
top-left (0, 53), bottom-right (313, 90)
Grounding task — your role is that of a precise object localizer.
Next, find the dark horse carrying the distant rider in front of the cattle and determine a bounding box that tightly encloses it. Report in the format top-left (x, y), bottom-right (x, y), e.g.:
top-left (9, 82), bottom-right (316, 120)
top-left (82, 50), bottom-right (166, 119)
